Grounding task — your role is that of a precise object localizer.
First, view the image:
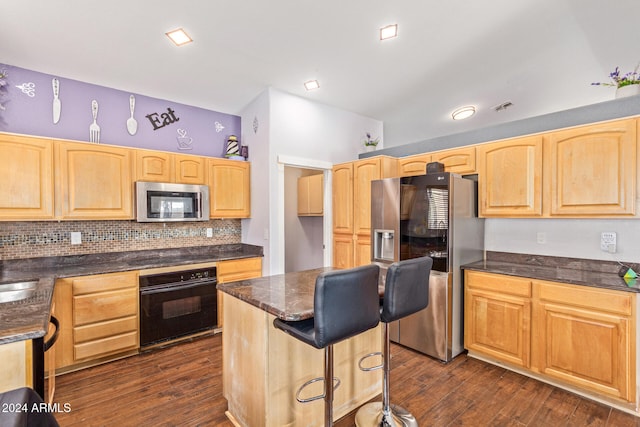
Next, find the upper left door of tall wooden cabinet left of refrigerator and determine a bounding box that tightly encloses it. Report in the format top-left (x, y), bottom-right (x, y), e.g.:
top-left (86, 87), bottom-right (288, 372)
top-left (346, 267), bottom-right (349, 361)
top-left (333, 163), bottom-right (353, 234)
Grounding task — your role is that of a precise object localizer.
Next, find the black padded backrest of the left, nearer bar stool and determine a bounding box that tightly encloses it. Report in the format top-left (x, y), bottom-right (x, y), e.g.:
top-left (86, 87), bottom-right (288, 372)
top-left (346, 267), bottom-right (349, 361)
top-left (313, 264), bottom-right (380, 348)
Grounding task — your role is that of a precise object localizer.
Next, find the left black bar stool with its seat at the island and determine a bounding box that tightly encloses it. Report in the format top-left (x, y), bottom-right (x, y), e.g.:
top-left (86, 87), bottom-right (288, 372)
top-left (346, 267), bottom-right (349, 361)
top-left (273, 264), bottom-right (380, 426)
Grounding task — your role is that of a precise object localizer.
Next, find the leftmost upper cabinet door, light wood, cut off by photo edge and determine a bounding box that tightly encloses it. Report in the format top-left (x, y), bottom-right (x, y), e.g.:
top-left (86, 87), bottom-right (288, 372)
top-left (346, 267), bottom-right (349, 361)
top-left (0, 134), bottom-right (53, 220)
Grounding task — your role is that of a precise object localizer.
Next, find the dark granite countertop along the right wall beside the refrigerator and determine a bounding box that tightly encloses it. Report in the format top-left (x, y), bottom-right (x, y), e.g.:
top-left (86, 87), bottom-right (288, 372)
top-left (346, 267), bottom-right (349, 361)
top-left (462, 252), bottom-right (640, 292)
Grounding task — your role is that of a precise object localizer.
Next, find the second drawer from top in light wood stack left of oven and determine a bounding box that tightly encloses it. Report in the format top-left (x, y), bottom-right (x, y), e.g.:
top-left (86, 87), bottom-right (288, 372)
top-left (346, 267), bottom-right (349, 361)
top-left (73, 288), bottom-right (138, 326)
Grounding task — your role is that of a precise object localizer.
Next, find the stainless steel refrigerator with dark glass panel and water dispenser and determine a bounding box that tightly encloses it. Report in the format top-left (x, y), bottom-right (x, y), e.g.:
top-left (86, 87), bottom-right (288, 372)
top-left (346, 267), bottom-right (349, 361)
top-left (371, 172), bottom-right (484, 362)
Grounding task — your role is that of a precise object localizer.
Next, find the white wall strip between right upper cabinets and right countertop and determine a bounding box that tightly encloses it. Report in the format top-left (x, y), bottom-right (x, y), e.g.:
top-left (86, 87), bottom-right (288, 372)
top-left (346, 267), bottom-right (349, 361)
top-left (484, 218), bottom-right (640, 262)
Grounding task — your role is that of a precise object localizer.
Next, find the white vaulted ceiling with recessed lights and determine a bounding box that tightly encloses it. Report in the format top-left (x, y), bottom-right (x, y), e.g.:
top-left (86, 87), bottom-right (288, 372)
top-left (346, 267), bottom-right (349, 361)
top-left (0, 0), bottom-right (640, 147)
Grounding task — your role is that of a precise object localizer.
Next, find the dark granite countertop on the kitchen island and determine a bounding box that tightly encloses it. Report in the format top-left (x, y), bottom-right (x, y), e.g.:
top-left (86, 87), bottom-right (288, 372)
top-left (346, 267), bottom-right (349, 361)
top-left (218, 267), bottom-right (384, 321)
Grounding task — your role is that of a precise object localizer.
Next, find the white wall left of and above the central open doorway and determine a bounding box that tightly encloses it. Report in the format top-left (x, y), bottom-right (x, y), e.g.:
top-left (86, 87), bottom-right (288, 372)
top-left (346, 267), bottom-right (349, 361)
top-left (240, 88), bottom-right (384, 274)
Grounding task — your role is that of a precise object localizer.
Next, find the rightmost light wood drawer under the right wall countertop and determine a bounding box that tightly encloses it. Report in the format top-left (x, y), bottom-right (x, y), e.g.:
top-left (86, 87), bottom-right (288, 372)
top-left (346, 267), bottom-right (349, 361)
top-left (536, 282), bottom-right (633, 316)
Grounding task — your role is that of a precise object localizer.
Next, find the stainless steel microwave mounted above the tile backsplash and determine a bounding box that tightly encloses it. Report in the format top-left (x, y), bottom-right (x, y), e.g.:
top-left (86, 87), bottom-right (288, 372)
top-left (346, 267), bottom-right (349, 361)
top-left (136, 181), bottom-right (209, 222)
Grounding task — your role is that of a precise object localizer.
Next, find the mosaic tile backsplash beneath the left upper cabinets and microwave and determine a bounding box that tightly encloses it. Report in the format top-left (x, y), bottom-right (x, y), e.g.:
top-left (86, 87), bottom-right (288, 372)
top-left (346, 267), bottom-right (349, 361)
top-left (0, 219), bottom-right (242, 260)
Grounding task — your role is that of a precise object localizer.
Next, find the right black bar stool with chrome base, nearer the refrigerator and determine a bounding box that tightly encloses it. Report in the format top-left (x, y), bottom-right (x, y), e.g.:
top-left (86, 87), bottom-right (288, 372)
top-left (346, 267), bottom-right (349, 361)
top-left (355, 257), bottom-right (433, 427)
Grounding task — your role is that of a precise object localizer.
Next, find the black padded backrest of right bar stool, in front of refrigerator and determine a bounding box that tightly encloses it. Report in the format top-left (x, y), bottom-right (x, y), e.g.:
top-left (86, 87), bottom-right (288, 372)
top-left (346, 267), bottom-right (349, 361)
top-left (380, 257), bottom-right (433, 323)
